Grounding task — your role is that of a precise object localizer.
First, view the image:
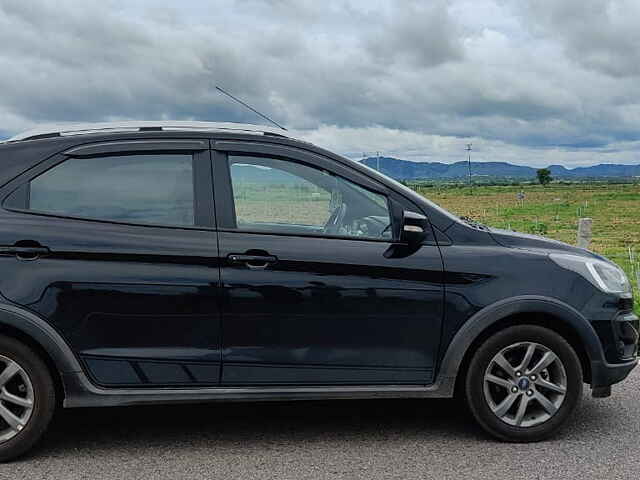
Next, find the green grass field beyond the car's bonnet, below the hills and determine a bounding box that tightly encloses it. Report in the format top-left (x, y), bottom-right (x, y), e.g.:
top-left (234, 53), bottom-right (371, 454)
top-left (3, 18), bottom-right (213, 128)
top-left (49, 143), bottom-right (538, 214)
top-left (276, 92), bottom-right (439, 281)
top-left (410, 183), bottom-right (640, 313)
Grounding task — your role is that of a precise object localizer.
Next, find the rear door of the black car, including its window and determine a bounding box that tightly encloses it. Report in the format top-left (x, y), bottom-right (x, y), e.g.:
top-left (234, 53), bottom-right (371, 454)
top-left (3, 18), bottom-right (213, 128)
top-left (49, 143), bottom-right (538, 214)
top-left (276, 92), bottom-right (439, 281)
top-left (0, 139), bottom-right (220, 386)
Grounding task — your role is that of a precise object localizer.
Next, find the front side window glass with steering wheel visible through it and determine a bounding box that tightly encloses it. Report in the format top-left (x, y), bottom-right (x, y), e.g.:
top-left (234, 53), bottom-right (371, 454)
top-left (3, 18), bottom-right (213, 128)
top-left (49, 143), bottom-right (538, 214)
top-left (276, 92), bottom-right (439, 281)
top-left (229, 156), bottom-right (391, 239)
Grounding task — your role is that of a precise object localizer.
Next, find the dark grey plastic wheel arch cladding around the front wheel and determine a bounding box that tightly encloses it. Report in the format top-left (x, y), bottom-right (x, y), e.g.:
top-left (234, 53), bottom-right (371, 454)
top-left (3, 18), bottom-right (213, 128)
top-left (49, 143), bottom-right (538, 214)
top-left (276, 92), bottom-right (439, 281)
top-left (439, 296), bottom-right (604, 392)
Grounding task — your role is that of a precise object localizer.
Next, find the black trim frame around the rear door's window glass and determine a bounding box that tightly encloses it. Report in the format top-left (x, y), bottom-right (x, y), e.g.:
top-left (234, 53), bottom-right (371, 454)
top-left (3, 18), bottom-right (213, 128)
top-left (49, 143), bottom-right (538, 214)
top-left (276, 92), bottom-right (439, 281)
top-left (1, 140), bottom-right (216, 230)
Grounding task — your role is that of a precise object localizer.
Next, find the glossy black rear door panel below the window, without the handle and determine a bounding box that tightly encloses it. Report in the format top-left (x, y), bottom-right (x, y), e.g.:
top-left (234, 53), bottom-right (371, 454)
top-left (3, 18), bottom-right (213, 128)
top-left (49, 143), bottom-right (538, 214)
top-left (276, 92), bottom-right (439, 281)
top-left (0, 142), bottom-right (221, 385)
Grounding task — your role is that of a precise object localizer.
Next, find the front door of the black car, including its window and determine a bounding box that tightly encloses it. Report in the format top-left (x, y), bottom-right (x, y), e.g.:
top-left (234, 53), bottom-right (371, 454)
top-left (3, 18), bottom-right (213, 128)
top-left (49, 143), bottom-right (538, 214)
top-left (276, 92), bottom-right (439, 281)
top-left (214, 147), bottom-right (442, 385)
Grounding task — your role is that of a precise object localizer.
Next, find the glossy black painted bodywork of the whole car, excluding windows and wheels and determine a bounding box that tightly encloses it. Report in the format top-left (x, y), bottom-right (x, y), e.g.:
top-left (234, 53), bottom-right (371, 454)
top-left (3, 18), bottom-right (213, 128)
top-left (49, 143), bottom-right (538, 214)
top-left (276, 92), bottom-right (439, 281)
top-left (0, 132), bottom-right (637, 406)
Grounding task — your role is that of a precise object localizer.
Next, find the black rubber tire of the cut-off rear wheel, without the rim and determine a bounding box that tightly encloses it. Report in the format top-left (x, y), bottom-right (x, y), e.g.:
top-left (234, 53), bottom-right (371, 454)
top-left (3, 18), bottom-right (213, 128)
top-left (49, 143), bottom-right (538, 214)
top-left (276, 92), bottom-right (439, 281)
top-left (0, 335), bottom-right (56, 462)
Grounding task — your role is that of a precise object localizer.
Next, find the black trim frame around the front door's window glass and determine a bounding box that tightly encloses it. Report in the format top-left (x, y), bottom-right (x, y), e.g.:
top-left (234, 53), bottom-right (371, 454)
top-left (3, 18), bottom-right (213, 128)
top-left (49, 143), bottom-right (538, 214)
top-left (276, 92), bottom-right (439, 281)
top-left (212, 149), bottom-right (399, 244)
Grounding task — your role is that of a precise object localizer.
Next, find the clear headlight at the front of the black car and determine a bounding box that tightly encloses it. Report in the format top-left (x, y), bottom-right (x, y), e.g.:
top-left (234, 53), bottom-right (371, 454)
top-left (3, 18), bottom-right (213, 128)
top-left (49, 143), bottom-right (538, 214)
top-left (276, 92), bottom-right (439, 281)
top-left (549, 253), bottom-right (631, 293)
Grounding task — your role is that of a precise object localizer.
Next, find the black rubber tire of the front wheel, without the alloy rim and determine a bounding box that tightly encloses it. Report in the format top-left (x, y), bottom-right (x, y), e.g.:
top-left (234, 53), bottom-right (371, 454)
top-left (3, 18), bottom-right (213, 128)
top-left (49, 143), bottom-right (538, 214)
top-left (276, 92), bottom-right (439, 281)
top-left (465, 325), bottom-right (583, 442)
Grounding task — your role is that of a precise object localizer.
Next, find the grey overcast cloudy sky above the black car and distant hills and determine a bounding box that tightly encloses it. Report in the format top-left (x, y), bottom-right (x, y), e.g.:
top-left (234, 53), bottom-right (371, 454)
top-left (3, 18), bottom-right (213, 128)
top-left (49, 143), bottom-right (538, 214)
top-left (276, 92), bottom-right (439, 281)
top-left (0, 0), bottom-right (640, 167)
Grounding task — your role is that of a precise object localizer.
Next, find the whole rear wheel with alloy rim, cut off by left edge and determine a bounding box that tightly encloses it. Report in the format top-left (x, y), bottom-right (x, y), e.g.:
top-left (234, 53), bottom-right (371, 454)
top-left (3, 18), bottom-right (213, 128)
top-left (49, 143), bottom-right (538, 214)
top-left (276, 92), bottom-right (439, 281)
top-left (0, 336), bottom-right (55, 461)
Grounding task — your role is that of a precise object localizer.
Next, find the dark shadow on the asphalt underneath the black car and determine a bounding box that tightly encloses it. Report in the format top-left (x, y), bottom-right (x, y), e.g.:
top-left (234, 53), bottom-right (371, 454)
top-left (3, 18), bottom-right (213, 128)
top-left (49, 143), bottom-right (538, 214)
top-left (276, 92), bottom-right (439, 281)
top-left (19, 399), bottom-right (611, 461)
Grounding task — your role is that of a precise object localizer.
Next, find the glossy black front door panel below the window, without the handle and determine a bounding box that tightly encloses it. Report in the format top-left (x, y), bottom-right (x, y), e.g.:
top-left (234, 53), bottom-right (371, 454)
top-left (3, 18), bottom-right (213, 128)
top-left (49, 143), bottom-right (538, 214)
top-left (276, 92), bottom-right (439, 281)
top-left (219, 232), bottom-right (442, 385)
